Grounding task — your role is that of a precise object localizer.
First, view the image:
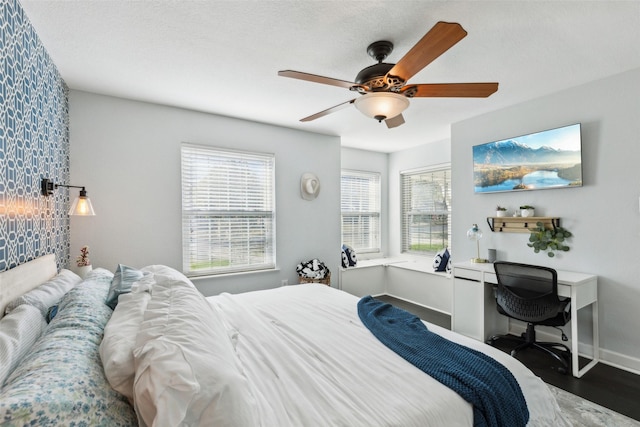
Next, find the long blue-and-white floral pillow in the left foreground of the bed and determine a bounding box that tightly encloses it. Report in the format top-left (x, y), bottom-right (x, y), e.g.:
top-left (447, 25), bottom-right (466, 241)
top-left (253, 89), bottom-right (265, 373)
top-left (0, 269), bottom-right (136, 427)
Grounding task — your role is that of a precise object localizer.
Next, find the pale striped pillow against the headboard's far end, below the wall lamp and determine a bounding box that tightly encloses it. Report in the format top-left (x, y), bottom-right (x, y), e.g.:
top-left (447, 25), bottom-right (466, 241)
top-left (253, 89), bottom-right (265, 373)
top-left (5, 268), bottom-right (82, 317)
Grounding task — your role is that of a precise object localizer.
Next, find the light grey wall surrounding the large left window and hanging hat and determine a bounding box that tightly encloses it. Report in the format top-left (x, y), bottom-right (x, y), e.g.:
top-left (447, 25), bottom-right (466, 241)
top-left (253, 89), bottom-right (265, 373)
top-left (69, 91), bottom-right (340, 295)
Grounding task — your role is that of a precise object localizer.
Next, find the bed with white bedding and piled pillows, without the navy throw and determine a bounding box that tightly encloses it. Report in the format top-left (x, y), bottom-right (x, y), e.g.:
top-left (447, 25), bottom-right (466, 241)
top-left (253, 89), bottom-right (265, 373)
top-left (0, 258), bottom-right (569, 427)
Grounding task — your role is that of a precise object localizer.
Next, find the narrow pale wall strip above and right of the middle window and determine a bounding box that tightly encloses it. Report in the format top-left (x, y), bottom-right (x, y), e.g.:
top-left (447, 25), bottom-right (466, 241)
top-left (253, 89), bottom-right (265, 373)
top-left (341, 148), bottom-right (389, 259)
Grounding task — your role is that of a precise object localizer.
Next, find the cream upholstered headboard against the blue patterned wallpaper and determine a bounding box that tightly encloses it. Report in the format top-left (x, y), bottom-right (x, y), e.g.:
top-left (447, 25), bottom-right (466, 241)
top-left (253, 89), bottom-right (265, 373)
top-left (0, 254), bottom-right (58, 319)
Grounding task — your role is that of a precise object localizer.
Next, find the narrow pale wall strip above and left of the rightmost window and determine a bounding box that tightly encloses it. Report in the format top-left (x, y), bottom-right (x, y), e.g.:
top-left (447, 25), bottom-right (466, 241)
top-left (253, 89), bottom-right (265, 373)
top-left (389, 140), bottom-right (455, 263)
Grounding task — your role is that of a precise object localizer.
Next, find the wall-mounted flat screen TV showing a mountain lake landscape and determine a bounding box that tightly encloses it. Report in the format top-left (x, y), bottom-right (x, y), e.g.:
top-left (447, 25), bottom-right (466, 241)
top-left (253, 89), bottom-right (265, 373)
top-left (473, 123), bottom-right (582, 193)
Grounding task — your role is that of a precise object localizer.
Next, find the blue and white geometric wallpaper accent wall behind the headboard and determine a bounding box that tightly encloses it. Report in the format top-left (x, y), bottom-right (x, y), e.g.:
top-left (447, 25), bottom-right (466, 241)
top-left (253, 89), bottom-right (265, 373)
top-left (0, 0), bottom-right (70, 271)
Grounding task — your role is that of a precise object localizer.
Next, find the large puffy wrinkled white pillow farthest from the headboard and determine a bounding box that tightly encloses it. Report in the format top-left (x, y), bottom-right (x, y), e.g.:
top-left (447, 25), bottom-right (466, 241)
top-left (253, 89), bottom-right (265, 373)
top-left (133, 280), bottom-right (258, 427)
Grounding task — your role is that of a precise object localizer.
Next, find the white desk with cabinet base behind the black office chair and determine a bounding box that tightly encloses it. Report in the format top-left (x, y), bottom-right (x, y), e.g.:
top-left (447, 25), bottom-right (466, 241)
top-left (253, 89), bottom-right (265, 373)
top-left (451, 262), bottom-right (600, 378)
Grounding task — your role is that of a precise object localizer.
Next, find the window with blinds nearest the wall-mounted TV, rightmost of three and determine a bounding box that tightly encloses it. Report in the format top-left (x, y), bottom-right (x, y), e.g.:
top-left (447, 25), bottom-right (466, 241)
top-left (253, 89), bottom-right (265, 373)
top-left (400, 166), bottom-right (451, 254)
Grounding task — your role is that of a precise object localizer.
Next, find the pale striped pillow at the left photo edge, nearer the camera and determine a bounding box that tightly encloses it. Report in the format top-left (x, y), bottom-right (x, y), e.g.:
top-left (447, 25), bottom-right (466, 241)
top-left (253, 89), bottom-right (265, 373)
top-left (0, 304), bottom-right (47, 388)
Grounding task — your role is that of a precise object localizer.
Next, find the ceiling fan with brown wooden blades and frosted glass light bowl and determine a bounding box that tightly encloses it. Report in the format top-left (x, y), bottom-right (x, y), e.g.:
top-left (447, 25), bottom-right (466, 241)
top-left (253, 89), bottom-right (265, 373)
top-left (278, 21), bottom-right (498, 128)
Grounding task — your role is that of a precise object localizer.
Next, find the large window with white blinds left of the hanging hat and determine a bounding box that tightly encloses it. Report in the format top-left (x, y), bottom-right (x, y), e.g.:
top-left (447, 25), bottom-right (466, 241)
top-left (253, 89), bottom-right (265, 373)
top-left (182, 144), bottom-right (275, 276)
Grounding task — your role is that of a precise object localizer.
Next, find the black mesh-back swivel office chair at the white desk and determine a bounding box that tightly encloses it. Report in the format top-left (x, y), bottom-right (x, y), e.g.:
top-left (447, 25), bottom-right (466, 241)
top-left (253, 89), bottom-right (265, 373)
top-left (487, 261), bottom-right (571, 374)
